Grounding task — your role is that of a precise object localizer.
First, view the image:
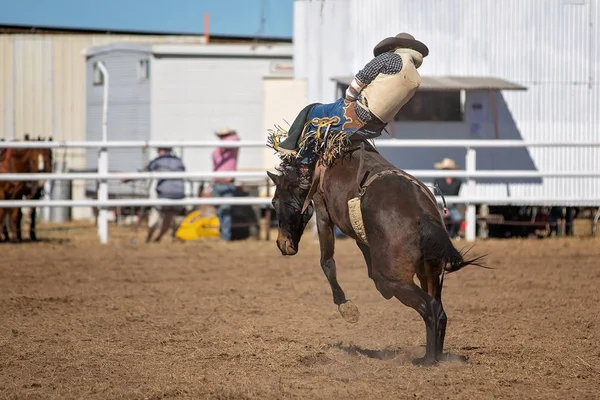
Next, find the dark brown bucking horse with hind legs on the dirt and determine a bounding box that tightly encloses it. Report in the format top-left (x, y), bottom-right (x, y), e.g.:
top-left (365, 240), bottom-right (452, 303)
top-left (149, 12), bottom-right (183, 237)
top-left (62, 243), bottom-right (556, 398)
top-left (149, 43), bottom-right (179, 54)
top-left (268, 141), bottom-right (484, 365)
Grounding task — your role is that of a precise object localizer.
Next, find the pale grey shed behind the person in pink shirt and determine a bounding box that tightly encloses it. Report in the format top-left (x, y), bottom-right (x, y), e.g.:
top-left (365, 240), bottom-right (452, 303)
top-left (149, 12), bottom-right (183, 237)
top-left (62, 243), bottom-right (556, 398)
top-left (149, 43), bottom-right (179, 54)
top-left (86, 43), bottom-right (293, 198)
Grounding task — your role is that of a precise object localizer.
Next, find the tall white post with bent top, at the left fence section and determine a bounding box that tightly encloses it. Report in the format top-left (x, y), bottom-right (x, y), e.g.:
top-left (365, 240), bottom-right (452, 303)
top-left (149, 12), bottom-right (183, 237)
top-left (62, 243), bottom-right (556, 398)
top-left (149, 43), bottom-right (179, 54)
top-left (97, 61), bottom-right (108, 244)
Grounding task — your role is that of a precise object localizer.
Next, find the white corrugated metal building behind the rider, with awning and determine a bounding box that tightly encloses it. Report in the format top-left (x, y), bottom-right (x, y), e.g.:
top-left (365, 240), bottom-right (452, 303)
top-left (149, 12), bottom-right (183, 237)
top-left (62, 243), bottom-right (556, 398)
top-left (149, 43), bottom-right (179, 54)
top-left (294, 0), bottom-right (600, 203)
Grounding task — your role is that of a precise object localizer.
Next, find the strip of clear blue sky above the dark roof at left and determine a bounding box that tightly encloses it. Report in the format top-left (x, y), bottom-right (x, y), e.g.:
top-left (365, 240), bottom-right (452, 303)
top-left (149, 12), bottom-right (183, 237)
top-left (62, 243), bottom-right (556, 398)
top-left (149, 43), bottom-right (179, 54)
top-left (0, 0), bottom-right (294, 39)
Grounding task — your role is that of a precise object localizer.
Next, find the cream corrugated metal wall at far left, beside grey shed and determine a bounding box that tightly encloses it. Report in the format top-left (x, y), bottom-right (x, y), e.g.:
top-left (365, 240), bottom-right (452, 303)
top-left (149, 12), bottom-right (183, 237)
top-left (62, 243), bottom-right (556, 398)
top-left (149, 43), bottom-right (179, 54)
top-left (0, 34), bottom-right (205, 219)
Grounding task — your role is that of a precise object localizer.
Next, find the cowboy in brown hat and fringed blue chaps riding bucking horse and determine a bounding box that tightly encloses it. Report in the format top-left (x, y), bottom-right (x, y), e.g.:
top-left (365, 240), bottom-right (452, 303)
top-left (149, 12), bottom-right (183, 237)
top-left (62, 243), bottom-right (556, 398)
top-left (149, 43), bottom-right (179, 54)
top-left (270, 33), bottom-right (429, 183)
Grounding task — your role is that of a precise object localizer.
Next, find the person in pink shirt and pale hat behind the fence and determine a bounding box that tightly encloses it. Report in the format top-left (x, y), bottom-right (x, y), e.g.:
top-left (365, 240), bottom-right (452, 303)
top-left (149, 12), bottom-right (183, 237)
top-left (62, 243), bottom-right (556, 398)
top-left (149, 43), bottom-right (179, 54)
top-left (212, 127), bottom-right (240, 240)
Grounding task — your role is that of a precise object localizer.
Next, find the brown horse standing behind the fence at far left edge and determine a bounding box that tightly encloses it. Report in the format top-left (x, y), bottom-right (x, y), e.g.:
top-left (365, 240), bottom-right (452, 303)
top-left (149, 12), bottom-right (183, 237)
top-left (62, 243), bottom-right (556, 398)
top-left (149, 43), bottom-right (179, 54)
top-left (0, 136), bottom-right (53, 242)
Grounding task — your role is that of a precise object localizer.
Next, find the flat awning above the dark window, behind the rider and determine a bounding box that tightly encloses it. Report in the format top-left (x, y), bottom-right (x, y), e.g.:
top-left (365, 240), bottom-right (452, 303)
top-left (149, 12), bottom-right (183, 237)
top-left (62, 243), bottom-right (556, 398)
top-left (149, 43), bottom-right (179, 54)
top-left (332, 75), bottom-right (527, 91)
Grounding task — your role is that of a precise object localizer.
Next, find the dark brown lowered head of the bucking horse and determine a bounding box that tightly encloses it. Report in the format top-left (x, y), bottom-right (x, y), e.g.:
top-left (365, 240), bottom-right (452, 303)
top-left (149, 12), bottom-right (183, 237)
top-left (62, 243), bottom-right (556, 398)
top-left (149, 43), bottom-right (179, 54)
top-left (267, 168), bottom-right (313, 256)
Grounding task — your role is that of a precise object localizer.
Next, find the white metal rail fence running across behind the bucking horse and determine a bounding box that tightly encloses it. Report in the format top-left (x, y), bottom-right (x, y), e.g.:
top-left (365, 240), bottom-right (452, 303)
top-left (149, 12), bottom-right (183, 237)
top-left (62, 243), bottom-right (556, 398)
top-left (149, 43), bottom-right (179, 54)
top-left (0, 139), bottom-right (600, 243)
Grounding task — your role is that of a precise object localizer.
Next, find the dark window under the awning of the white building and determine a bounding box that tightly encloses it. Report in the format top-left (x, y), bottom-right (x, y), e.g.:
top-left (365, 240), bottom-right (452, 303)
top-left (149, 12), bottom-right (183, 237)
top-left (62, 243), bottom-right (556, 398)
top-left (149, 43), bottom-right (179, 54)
top-left (394, 90), bottom-right (463, 122)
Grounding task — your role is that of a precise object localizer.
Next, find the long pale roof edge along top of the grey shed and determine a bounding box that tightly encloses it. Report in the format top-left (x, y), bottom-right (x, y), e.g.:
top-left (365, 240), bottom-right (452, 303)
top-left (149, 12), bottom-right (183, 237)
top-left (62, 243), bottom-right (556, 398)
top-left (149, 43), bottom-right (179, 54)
top-left (85, 42), bottom-right (294, 59)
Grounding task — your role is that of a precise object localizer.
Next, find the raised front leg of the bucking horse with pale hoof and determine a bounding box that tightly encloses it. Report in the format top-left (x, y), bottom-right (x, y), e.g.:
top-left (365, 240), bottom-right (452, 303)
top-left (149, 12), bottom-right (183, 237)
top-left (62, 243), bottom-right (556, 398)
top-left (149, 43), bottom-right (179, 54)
top-left (314, 199), bottom-right (360, 323)
